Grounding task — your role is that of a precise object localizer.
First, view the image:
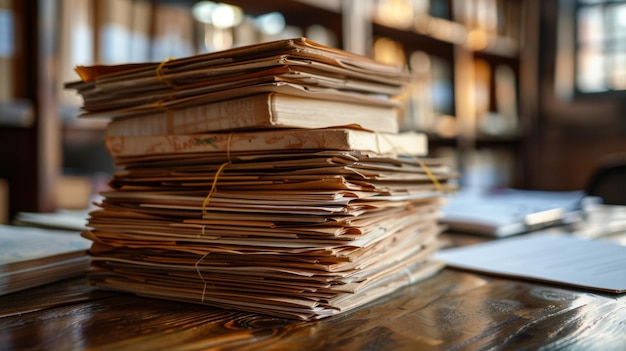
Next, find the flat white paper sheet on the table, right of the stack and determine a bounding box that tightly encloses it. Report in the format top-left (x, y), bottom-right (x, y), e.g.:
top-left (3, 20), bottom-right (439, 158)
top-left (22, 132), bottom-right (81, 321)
top-left (435, 233), bottom-right (626, 293)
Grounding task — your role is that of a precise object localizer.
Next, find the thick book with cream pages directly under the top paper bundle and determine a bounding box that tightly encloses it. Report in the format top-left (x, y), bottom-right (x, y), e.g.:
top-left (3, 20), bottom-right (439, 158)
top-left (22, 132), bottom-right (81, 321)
top-left (106, 92), bottom-right (399, 136)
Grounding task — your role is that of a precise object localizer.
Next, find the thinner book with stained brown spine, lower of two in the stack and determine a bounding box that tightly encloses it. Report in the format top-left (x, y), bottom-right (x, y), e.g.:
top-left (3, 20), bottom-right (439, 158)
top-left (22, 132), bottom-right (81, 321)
top-left (105, 128), bottom-right (428, 157)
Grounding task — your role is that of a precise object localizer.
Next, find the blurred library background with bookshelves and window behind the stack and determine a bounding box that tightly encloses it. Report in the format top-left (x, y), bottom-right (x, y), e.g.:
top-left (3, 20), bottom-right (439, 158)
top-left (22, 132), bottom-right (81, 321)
top-left (0, 0), bottom-right (626, 223)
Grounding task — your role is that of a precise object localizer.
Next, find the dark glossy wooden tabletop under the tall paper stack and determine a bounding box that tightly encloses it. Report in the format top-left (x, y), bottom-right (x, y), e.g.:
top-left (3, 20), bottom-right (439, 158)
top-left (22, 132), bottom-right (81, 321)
top-left (0, 234), bottom-right (626, 351)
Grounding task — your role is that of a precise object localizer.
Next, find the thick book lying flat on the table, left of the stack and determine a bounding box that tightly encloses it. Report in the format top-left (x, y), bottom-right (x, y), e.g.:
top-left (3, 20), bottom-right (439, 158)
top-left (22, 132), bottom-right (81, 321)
top-left (0, 225), bottom-right (91, 295)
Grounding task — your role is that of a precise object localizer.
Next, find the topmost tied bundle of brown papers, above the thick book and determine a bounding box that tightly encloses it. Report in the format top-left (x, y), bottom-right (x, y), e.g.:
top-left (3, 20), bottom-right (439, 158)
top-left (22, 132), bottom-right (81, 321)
top-left (66, 38), bottom-right (410, 131)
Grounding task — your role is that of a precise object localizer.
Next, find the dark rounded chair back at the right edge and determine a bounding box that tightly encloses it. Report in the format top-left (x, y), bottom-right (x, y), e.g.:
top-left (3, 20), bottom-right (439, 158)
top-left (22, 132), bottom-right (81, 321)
top-left (585, 153), bottom-right (626, 205)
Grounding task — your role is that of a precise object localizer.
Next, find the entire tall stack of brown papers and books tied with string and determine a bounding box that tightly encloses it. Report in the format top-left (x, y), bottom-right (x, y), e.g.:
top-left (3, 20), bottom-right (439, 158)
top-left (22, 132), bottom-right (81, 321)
top-left (67, 38), bottom-right (454, 320)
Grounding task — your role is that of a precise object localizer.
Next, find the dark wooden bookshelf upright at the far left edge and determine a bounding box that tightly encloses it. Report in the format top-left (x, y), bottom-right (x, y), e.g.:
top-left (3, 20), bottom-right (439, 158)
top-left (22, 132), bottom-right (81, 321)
top-left (0, 0), bottom-right (60, 219)
